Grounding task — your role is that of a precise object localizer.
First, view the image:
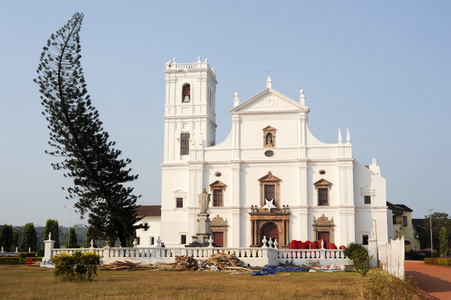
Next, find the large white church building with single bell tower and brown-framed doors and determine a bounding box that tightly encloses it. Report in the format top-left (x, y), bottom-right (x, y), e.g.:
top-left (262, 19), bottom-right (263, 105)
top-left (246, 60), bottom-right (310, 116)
top-left (137, 58), bottom-right (388, 248)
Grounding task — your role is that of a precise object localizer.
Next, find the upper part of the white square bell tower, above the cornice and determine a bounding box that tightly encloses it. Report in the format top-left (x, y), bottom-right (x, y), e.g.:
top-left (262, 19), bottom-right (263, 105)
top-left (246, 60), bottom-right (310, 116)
top-left (164, 57), bottom-right (218, 162)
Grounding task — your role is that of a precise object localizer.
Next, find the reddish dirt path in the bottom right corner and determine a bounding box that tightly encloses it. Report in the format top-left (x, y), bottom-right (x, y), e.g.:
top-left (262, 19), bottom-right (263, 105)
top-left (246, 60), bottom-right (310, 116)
top-left (405, 260), bottom-right (451, 299)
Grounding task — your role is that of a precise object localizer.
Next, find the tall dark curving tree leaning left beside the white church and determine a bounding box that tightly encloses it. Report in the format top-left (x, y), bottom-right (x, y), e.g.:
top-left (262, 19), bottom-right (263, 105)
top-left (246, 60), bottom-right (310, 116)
top-left (35, 13), bottom-right (140, 246)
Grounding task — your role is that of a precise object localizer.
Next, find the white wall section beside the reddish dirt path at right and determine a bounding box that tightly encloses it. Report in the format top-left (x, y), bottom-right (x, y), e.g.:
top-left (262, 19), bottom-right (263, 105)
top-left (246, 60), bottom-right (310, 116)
top-left (378, 236), bottom-right (405, 280)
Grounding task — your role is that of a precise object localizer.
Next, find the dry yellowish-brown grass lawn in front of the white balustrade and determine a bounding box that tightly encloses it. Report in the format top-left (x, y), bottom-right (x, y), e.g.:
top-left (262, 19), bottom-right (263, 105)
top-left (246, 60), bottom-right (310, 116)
top-left (0, 265), bottom-right (368, 299)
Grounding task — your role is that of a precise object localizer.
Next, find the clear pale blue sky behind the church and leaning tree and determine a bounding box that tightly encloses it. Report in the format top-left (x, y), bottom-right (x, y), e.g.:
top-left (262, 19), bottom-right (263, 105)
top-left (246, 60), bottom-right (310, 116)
top-left (0, 0), bottom-right (451, 226)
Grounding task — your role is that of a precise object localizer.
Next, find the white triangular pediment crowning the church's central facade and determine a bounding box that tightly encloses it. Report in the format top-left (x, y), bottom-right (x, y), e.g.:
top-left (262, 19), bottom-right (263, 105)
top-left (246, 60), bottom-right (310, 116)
top-left (230, 88), bottom-right (309, 114)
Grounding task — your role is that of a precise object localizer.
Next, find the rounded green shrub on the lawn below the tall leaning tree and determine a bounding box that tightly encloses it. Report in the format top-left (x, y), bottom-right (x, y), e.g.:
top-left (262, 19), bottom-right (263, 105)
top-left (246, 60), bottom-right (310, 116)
top-left (52, 251), bottom-right (100, 281)
